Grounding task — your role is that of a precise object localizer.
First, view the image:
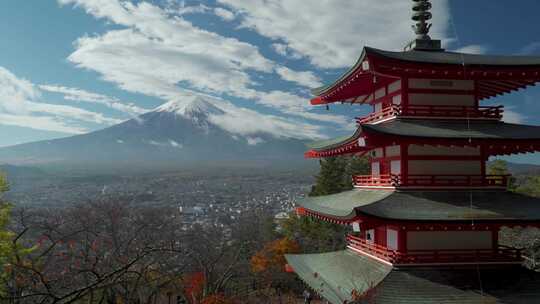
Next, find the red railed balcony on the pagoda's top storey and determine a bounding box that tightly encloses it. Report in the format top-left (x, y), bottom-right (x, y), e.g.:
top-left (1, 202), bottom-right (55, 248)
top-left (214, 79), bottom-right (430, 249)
top-left (356, 105), bottom-right (504, 124)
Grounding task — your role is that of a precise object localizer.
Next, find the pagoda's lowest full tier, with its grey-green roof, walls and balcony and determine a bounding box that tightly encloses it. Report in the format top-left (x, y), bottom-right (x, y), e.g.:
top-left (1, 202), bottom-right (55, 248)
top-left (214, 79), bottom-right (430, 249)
top-left (296, 189), bottom-right (540, 266)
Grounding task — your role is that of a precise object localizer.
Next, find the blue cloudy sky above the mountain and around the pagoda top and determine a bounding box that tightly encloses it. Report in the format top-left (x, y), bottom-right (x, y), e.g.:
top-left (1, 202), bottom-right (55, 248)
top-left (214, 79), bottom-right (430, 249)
top-left (0, 0), bottom-right (540, 164)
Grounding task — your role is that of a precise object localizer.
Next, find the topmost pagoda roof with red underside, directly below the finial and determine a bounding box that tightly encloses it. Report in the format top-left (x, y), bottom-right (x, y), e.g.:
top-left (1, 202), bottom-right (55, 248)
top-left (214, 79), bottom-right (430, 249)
top-left (311, 47), bottom-right (540, 104)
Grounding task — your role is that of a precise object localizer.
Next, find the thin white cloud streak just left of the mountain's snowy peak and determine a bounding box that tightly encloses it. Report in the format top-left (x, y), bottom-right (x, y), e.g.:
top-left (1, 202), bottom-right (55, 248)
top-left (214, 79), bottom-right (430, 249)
top-left (39, 85), bottom-right (148, 116)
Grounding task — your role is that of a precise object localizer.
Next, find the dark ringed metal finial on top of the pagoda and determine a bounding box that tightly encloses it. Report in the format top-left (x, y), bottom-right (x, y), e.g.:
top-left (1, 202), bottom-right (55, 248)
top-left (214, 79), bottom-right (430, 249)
top-left (405, 0), bottom-right (443, 51)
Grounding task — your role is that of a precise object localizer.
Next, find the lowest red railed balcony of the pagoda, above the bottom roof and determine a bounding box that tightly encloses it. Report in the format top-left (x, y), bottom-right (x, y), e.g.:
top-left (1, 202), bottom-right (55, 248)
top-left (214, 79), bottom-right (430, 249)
top-left (347, 235), bottom-right (523, 265)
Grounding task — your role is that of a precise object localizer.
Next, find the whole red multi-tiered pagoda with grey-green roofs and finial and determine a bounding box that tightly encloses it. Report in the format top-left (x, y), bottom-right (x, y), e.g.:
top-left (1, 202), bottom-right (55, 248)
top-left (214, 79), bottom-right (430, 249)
top-left (286, 0), bottom-right (540, 304)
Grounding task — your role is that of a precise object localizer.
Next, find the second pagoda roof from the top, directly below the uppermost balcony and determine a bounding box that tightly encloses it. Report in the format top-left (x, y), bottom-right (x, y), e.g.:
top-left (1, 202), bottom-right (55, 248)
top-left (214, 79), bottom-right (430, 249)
top-left (306, 118), bottom-right (540, 158)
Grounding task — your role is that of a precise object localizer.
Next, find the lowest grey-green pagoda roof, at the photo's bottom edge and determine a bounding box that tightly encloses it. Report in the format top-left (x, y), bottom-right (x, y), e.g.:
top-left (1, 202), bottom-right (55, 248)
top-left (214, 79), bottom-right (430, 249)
top-left (285, 250), bottom-right (540, 304)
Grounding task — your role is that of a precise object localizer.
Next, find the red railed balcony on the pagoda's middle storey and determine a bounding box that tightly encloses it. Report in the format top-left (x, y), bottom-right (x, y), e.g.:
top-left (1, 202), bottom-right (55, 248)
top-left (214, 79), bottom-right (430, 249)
top-left (353, 174), bottom-right (510, 189)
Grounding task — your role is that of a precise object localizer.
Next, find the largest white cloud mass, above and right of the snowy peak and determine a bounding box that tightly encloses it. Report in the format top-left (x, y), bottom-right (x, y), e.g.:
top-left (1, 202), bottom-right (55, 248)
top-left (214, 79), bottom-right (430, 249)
top-left (60, 0), bottom-right (352, 136)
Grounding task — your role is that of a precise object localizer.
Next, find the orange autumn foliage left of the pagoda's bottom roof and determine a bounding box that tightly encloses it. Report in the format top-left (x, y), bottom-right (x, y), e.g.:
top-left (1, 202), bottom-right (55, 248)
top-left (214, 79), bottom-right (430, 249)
top-left (251, 238), bottom-right (300, 273)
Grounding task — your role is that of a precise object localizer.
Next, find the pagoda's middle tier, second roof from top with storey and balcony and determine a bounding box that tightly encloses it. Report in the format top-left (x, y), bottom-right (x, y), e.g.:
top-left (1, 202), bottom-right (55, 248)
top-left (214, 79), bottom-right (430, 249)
top-left (305, 118), bottom-right (540, 189)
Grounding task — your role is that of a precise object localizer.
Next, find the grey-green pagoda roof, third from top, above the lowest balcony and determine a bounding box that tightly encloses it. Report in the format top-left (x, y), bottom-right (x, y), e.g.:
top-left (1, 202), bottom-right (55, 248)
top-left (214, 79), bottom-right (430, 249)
top-left (296, 189), bottom-right (540, 222)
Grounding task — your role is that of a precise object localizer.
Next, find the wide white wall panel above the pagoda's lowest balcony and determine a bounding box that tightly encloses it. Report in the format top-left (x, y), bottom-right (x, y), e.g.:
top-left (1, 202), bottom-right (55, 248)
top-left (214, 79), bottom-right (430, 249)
top-left (407, 231), bottom-right (493, 251)
